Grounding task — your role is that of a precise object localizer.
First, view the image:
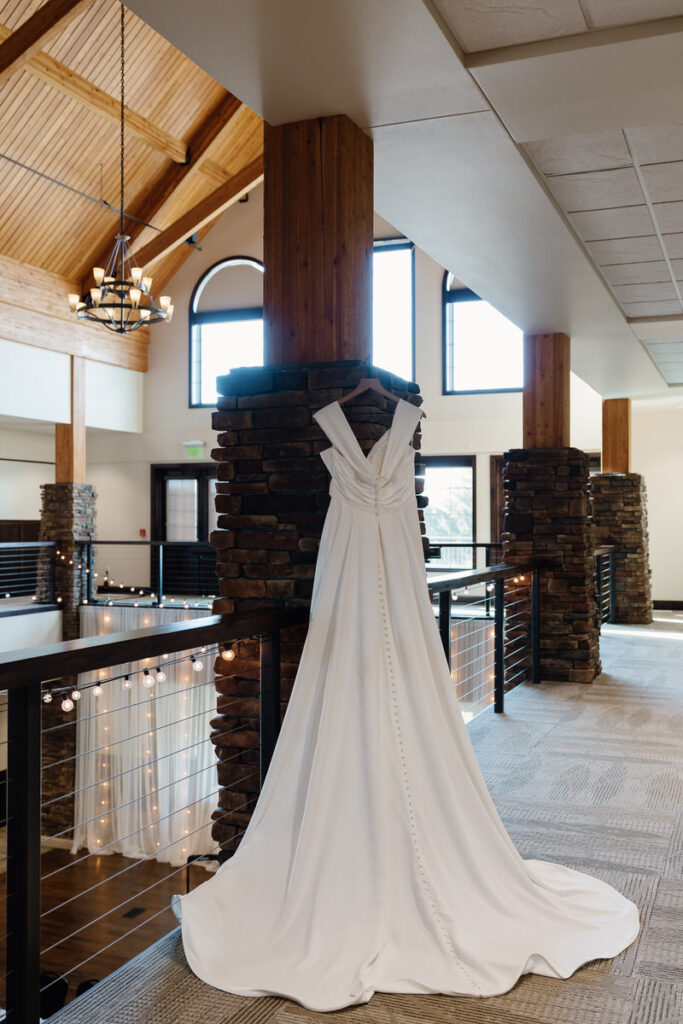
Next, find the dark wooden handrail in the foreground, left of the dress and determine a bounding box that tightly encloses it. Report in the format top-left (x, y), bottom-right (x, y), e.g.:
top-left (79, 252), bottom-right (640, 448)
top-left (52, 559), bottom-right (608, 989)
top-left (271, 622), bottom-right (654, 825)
top-left (0, 606), bottom-right (309, 690)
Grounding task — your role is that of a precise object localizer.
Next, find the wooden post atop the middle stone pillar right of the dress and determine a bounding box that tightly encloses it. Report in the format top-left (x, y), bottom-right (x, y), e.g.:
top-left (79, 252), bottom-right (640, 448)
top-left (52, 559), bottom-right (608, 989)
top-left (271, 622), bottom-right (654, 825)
top-left (523, 334), bottom-right (570, 449)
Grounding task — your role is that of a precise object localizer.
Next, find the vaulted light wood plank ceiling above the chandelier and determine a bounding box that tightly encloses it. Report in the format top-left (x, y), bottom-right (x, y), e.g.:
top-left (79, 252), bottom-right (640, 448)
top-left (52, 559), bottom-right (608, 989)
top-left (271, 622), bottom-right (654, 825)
top-left (0, 0), bottom-right (263, 303)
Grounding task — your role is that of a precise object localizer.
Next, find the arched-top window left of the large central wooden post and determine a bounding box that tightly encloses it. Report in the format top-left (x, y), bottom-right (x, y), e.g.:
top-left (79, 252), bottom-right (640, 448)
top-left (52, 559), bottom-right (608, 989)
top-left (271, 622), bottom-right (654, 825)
top-left (189, 256), bottom-right (263, 407)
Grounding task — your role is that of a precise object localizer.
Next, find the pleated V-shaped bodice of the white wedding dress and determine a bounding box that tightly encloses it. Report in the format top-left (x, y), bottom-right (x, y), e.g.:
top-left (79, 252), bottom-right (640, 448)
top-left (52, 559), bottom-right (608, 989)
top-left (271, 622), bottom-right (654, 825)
top-left (313, 398), bottom-right (421, 515)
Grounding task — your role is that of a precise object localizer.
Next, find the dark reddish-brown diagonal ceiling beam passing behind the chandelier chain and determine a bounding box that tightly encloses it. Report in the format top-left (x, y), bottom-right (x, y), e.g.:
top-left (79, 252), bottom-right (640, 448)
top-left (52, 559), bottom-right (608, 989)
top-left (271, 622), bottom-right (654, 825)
top-left (82, 92), bottom-right (242, 293)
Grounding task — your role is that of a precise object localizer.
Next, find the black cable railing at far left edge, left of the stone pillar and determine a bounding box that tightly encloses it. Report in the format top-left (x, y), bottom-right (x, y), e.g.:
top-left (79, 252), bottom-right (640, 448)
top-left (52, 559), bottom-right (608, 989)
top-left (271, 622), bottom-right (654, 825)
top-left (0, 541), bottom-right (55, 611)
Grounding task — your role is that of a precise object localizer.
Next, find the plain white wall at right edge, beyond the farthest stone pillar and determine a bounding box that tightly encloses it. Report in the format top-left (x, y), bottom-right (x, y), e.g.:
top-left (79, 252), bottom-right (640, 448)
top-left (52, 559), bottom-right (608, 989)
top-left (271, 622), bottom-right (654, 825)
top-left (632, 396), bottom-right (683, 601)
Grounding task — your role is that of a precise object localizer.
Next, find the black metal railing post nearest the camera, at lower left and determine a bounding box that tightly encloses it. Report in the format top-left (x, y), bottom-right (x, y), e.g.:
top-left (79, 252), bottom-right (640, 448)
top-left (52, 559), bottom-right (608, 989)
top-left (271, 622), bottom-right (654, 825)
top-left (6, 683), bottom-right (41, 1024)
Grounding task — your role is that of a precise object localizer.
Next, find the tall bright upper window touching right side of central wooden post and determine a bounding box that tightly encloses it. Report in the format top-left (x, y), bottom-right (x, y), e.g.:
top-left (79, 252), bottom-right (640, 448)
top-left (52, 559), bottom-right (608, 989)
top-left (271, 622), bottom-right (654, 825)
top-left (373, 239), bottom-right (415, 381)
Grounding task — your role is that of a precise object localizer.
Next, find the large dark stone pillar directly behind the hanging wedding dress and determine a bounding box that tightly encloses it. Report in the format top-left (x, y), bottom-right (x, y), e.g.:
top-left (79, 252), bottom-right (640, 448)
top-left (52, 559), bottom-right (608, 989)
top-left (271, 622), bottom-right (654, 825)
top-left (211, 360), bottom-right (427, 850)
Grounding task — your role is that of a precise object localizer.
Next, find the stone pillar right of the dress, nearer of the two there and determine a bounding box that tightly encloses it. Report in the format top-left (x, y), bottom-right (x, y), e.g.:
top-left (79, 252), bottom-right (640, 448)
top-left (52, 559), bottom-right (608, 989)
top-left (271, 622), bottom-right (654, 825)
top-left (502, 447), bottom-right (601, 683)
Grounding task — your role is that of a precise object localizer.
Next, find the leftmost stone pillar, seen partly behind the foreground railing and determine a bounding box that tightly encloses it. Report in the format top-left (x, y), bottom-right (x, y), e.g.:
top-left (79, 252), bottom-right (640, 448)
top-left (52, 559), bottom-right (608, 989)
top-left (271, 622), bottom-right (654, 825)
top-left (40, 483), bottom-right (95, 836)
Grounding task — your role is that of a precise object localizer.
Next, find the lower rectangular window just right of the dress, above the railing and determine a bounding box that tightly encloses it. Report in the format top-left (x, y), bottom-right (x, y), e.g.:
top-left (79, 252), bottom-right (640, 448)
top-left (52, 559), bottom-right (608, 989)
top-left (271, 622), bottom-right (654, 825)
top-left (422, 456), bottom-right (475, 571)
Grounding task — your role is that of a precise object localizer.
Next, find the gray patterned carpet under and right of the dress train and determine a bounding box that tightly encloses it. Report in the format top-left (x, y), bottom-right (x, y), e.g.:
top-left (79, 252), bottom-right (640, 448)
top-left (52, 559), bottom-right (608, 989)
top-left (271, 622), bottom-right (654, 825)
top-left (51, 618), bottom-right (683, 1024)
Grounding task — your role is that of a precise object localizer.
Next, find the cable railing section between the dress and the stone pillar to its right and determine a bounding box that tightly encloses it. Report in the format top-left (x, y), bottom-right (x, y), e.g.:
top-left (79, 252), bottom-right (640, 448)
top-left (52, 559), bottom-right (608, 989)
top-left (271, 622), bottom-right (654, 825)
top-left (428, 561), bottom-right (540, 721)
